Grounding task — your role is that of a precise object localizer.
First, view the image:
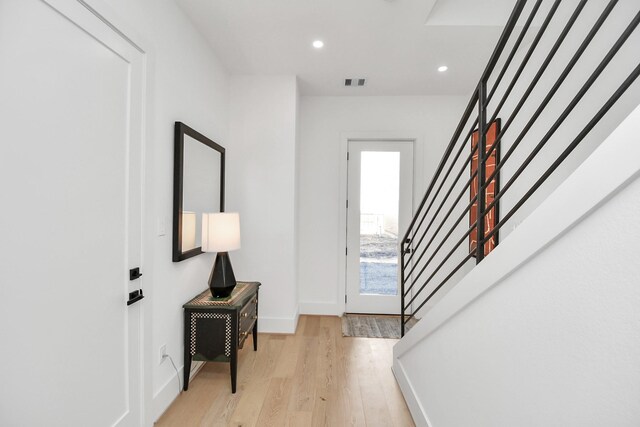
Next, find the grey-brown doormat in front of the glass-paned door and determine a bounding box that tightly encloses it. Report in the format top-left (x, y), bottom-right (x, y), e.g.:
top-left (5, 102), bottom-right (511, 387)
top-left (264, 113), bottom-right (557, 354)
top-left (342, 314), bottom-right (416, 339)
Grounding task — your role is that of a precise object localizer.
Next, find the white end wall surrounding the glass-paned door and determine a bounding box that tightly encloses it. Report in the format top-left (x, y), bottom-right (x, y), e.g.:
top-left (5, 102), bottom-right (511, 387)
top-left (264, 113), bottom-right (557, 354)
top-left (298, 96), bottom-right (467, 314)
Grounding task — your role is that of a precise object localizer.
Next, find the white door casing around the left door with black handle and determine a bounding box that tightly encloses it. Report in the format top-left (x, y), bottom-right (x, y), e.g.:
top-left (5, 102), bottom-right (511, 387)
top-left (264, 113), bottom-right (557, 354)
top-left (41, 0), bottom-right (156, 426)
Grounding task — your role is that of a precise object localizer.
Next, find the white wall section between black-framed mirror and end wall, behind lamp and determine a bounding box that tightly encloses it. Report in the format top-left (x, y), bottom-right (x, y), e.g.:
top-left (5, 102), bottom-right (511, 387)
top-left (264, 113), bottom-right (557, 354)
top-left (227, 76), bottom-right (298, 333)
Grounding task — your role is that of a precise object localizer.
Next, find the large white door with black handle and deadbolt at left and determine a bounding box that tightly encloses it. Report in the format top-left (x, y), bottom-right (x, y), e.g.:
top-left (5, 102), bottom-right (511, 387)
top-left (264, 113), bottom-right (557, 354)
top-left (0, 0), bottom-right (144, 426)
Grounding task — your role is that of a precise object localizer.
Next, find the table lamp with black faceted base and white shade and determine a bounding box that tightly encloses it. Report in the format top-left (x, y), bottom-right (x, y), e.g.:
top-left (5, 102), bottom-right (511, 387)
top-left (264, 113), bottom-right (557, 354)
top-left (202, 212), bottom-right (240, 298)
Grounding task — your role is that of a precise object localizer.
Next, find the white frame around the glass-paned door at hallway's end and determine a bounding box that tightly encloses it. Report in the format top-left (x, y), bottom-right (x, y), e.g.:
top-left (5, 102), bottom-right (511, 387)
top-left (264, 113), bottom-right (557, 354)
top-left (336, 131), bottom-right (425, 316)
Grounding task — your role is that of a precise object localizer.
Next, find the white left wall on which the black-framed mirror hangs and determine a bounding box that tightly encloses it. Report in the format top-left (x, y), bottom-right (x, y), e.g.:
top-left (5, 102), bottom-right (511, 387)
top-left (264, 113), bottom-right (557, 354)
top-left (97, 0), bottom-right (231, 422)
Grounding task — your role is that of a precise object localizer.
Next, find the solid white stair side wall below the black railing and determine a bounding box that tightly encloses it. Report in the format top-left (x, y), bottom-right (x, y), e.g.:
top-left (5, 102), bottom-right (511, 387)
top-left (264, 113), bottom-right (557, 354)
top-left (393, 107), bottom-right (640, 427)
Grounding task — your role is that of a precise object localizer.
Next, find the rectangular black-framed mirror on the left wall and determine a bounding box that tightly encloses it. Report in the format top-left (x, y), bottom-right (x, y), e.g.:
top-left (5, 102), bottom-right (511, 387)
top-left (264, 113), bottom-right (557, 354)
top-left (173, 122), bottom-right (225, 262)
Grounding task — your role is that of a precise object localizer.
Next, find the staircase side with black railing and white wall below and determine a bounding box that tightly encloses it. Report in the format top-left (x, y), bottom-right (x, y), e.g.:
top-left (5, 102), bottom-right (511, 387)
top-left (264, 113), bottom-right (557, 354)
top-left (393, 0), bottom-right (640, 427)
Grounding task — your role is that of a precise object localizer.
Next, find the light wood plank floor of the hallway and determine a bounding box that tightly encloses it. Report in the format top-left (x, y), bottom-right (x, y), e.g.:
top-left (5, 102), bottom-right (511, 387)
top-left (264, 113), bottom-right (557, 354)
top-left (156, 316), bottom-right (414, 427)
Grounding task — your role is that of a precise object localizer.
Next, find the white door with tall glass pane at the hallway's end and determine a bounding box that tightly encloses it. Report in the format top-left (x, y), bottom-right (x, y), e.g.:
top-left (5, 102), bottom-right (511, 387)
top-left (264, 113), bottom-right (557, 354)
top-left (346, 141), bottom-right (413, 314)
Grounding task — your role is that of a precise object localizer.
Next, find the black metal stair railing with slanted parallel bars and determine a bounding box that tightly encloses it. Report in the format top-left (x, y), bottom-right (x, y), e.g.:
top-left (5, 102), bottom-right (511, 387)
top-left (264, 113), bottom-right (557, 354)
top-left (400, 0), bottom-right (640, 336)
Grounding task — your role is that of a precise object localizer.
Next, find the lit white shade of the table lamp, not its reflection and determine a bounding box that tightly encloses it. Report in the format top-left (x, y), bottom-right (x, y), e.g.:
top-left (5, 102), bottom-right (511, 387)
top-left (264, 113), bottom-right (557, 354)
top-left (202, 212), bottom-right (240, 252)
